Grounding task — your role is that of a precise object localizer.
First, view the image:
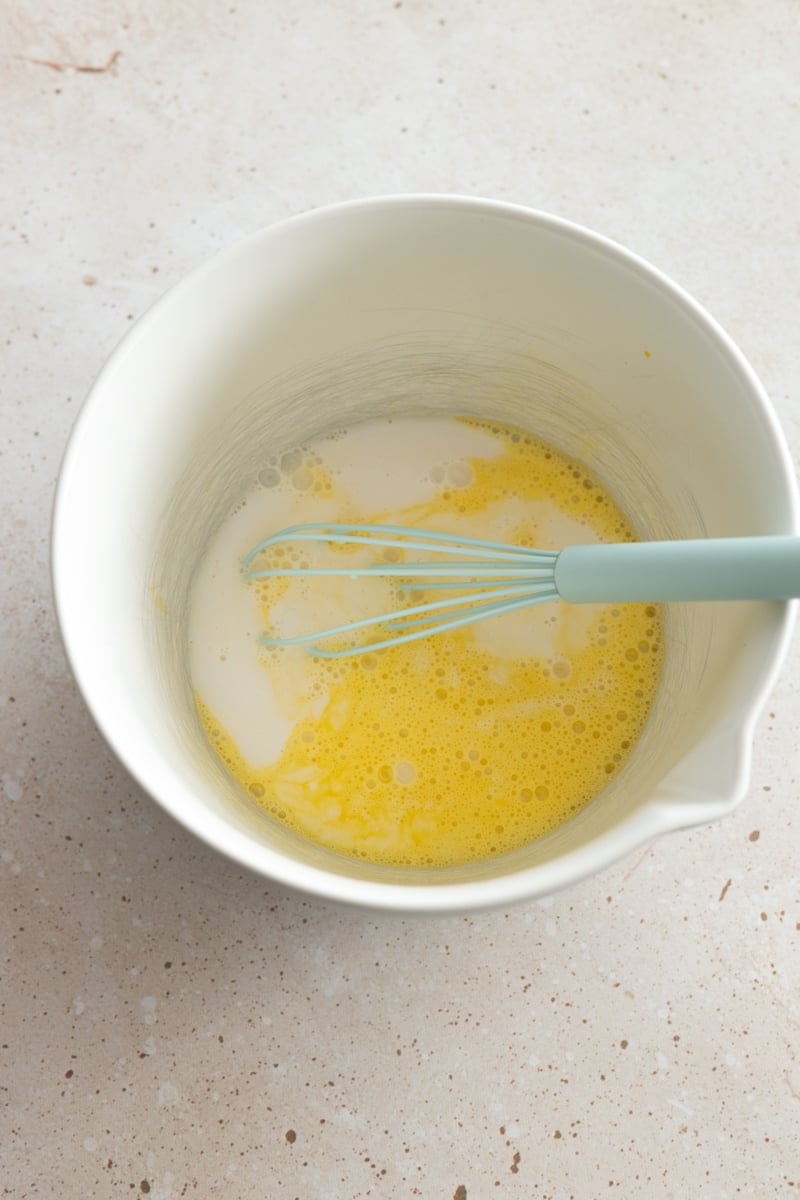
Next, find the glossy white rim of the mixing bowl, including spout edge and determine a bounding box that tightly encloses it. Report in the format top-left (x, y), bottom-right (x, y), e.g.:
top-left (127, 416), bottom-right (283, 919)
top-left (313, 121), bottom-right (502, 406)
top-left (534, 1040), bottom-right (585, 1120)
top-left (50, 192), bottom-right (800, 916)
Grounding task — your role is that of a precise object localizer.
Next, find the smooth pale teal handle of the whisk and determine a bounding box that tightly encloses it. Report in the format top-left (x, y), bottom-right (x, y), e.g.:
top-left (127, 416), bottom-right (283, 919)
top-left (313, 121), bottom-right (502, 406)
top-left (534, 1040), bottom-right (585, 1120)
top-left (554, 536), bottom-right (800, 604)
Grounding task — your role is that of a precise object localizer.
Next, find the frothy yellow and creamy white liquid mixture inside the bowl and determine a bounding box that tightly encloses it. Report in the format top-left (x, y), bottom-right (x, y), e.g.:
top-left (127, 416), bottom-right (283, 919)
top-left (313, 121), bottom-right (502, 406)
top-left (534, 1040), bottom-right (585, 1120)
top-left (190, 416), bottom-right (663, 866)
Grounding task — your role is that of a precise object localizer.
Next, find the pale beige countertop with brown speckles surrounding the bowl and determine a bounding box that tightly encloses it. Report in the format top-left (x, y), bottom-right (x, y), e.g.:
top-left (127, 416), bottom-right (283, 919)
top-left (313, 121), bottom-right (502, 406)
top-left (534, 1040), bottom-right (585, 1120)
top-left (0, 0), bottom-right (800, 1200)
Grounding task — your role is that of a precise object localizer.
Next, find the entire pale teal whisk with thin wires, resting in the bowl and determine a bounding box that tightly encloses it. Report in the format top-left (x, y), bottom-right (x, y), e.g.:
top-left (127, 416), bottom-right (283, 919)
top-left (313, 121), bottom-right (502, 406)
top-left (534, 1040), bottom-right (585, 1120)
top-left (242, 522), bottom-right (800, 659)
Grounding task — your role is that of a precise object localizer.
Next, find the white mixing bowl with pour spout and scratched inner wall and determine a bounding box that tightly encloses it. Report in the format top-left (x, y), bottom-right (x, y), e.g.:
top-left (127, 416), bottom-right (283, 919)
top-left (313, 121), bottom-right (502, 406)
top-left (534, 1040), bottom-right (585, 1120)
top-left (53, 196), bottom-right (799, 913)
